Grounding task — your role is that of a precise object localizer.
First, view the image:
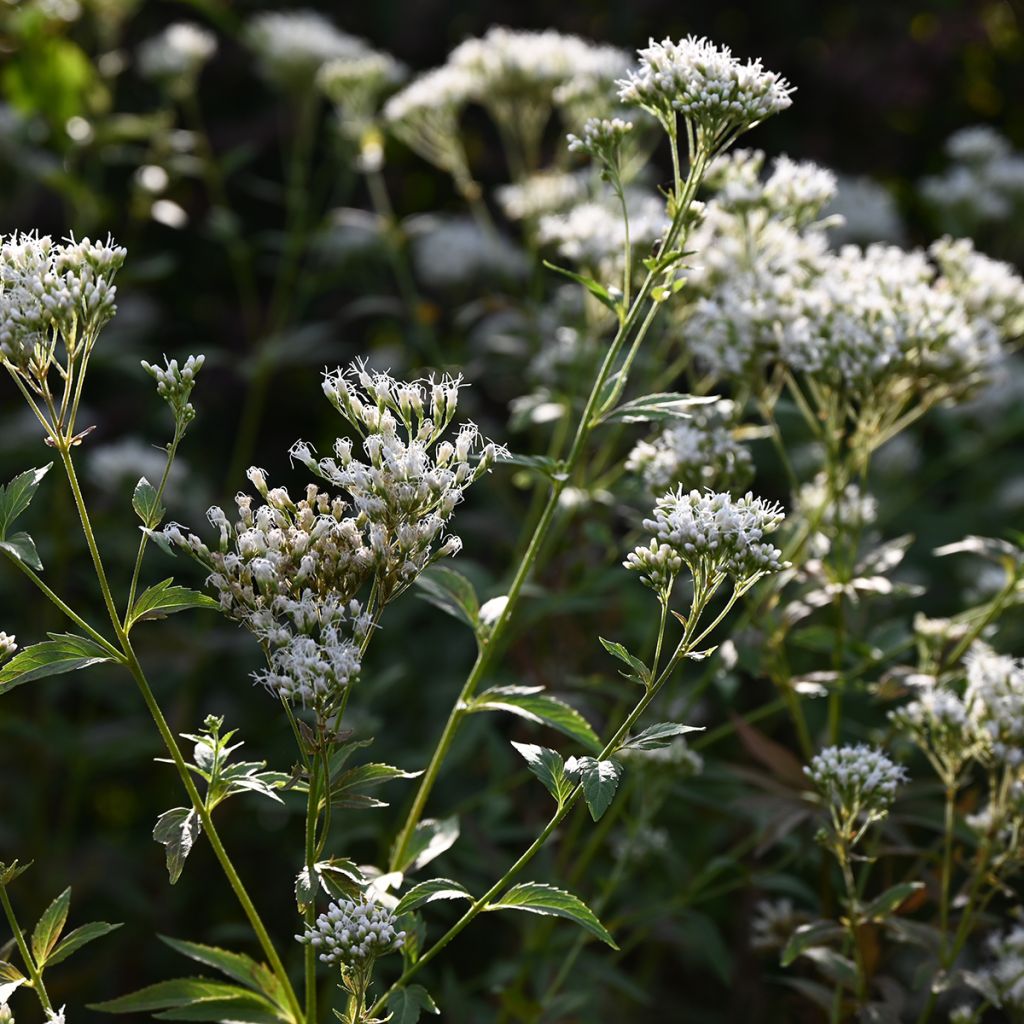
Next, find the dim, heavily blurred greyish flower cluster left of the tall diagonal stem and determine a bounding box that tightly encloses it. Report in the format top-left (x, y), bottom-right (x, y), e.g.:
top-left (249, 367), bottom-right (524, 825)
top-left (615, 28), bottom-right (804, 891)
top-left (410, 217), bottom-right (526, 290)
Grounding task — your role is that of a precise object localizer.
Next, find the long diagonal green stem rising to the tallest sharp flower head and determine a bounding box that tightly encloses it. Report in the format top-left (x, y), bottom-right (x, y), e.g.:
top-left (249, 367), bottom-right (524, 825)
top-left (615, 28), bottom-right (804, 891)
top-left (391, 148), bottom-right (706, 870)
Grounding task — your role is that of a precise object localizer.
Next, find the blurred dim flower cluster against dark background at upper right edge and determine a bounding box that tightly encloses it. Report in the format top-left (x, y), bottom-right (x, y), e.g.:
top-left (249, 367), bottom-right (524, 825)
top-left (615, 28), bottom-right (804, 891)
top-left (920, 125), bottom-right (1024, 234)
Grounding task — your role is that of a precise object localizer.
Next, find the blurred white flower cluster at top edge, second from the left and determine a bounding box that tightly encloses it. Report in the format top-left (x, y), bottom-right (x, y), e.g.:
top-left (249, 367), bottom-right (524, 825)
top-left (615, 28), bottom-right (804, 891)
top-left (246, 10), bottom-right (369, 88)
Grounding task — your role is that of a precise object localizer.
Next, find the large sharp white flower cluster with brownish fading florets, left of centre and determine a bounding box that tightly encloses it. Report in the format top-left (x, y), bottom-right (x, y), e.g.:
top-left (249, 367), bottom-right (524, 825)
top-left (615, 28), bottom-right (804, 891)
top-left (164, 364), bottom-right (501, 717)
